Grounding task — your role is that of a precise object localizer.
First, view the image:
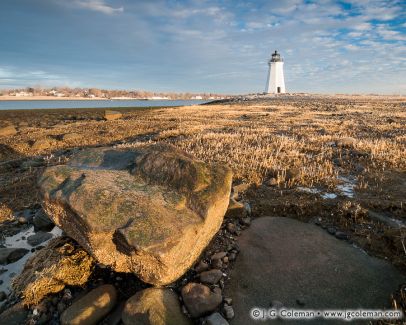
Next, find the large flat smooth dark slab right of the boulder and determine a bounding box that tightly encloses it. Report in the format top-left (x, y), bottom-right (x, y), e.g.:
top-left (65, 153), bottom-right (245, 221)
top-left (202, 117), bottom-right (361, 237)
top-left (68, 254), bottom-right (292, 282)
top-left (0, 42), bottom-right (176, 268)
top-left (224, 217), bottom-right (405, 325)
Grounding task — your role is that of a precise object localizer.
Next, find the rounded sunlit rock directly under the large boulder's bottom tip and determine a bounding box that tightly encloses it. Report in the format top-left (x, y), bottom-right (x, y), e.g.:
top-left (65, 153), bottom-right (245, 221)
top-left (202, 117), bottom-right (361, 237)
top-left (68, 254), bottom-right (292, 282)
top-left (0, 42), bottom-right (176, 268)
top-left (121, 288), bottom-right (192, 325)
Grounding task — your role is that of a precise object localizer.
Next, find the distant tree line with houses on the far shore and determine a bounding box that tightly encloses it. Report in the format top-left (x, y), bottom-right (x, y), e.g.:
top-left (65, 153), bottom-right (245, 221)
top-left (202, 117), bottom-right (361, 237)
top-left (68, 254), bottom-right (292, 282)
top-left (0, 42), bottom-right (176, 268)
top-left (0, 87), bottom-right (230, 99)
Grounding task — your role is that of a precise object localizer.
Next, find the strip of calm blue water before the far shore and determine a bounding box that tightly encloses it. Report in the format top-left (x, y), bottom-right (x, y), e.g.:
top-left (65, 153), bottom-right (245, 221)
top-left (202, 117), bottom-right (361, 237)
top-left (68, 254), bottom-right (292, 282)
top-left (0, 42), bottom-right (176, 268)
top-left (0, 99), bottom-right (207, 110)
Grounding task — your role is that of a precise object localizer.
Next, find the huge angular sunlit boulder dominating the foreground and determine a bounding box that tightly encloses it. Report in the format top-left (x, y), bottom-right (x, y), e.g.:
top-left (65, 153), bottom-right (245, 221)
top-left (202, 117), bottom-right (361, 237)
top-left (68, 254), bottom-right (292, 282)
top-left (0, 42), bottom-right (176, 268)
top-left (39, 144), bottom-right (232, 285)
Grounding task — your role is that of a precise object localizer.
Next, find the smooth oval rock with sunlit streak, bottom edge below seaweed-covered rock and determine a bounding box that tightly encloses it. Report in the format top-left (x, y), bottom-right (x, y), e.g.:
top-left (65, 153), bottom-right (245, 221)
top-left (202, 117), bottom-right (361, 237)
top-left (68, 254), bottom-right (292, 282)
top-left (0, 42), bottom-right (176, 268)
top-left (61, 284), bottom-right (117, 325)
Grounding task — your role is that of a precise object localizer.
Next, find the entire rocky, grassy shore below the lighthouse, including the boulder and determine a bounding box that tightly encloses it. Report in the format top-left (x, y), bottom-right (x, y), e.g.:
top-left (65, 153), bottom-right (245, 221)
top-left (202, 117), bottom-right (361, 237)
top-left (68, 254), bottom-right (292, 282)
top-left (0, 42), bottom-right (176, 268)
top-left (0, 96), bottom-right (406, 325)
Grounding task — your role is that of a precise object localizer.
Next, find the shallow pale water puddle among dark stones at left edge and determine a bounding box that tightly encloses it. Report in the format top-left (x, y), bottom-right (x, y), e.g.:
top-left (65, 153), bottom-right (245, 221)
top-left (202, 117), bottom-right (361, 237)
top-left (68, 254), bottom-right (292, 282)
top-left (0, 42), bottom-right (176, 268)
top-left (0, 226), bottom-right (62, 300)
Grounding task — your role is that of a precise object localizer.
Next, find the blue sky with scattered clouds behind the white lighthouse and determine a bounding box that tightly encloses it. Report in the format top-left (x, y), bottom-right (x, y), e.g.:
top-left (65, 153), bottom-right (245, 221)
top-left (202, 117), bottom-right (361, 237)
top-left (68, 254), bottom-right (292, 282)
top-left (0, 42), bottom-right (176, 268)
top-left (0, 0), bottom-right (406, 94)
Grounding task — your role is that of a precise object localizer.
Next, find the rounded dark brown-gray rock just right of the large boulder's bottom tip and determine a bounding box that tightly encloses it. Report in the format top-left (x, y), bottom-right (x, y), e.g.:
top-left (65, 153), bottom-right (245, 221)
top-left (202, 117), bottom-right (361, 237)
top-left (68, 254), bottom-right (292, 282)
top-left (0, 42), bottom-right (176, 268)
top-left (182, 282), bottom-right (223, 317)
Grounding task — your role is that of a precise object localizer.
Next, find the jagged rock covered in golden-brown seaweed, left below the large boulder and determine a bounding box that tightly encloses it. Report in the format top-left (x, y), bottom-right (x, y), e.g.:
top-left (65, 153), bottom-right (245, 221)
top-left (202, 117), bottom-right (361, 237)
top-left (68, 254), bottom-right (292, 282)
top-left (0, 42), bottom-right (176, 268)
top-left (13, 237), bottom-right (94, 305)
